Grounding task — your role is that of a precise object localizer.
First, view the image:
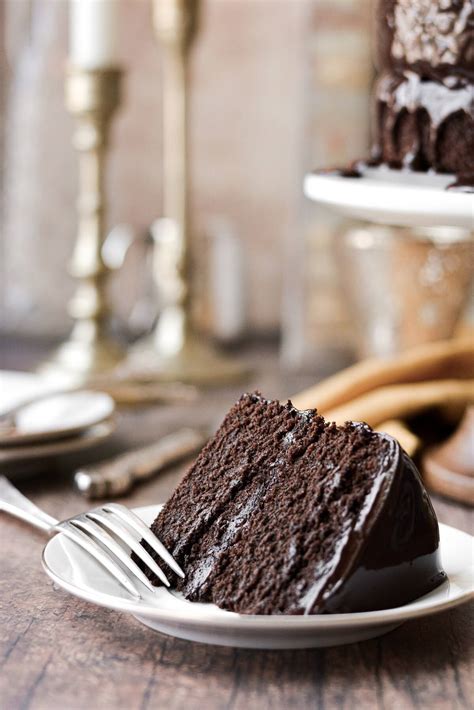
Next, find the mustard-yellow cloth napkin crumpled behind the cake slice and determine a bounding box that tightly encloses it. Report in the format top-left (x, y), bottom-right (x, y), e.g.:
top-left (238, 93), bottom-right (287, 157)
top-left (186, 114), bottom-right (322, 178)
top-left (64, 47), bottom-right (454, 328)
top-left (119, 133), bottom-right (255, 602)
top-left (292, 337), bottom-right (474, 454)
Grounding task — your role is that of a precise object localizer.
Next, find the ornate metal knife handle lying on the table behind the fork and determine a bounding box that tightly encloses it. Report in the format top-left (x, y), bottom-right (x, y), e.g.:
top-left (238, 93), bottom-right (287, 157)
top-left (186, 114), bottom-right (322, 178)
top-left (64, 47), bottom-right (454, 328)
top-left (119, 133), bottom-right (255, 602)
top-left (74, 428), bottom-right (206, 499)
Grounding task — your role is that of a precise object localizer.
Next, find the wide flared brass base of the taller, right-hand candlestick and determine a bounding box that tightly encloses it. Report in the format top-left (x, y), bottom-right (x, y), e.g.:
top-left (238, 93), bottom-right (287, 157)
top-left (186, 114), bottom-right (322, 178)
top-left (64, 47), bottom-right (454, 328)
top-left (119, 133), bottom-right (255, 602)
top-left (126, 333), bottom-right (250, 386)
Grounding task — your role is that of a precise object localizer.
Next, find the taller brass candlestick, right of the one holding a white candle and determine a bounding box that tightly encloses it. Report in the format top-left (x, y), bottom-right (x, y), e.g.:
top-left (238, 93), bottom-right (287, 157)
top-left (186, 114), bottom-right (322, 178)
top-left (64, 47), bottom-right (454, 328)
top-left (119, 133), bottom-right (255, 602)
top-left (131, 0), bottom-right (248, 384)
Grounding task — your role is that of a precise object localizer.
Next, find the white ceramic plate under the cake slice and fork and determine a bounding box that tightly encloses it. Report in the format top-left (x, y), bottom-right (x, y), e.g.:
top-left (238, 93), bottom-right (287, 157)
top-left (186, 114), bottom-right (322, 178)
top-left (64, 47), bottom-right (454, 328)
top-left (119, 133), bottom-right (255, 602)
top-left (43, 506), bottom-right (474, 649)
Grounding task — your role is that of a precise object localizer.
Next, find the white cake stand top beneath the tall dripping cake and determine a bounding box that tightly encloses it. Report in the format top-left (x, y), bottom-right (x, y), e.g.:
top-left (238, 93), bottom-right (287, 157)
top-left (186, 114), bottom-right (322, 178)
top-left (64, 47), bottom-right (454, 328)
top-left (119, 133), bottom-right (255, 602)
top-left (304, 166), bottom-right (474, 229)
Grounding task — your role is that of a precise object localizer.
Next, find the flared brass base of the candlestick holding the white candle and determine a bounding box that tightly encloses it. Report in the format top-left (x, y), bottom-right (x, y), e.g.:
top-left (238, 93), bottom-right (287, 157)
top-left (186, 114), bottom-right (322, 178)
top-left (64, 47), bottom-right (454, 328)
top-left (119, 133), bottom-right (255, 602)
top-left (38, 322), bottom-right (125, 384)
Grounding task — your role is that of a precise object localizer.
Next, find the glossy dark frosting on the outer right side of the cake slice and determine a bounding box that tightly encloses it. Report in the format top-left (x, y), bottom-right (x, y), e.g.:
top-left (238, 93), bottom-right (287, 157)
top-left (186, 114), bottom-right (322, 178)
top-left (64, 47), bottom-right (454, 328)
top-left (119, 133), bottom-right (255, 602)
top-left (308, 437), bottom-right (447, 613)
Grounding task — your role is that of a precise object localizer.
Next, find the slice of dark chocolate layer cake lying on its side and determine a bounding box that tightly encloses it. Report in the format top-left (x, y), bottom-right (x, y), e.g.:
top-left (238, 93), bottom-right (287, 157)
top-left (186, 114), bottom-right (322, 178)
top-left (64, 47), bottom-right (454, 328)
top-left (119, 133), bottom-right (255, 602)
top-left (144, 394), bottom-right (446, 614)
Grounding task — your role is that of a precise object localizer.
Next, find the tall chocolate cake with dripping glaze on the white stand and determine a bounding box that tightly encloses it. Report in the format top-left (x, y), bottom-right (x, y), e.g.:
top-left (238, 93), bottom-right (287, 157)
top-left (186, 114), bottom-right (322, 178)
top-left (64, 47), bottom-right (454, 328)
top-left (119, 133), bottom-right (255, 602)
top-left (373, 0), bottom-right (474, 178)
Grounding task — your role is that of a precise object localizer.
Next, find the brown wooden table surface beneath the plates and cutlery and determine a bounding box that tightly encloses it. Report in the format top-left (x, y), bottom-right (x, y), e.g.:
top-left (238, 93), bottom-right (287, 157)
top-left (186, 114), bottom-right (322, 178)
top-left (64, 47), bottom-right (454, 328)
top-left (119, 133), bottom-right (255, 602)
top-left (0, 342), bottom-right (474, 710)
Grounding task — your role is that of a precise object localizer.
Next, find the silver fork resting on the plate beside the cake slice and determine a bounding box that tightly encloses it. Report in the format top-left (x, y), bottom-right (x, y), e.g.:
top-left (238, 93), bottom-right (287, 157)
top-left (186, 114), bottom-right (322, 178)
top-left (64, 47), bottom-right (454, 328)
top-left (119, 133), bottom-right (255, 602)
top-left (0, 476), bottom-right (184, 599)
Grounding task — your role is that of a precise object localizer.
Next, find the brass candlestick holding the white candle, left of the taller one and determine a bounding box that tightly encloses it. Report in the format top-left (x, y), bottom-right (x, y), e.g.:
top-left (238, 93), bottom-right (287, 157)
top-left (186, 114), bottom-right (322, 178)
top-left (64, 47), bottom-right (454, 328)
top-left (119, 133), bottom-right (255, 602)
top-left (40, 67), bottom-right (124, 381)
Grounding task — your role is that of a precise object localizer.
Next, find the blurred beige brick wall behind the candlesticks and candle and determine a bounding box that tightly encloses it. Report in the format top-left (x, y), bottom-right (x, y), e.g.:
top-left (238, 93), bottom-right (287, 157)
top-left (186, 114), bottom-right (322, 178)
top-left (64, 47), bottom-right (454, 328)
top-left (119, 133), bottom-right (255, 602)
top-left (0, 0), bottom-right (370, 346)
